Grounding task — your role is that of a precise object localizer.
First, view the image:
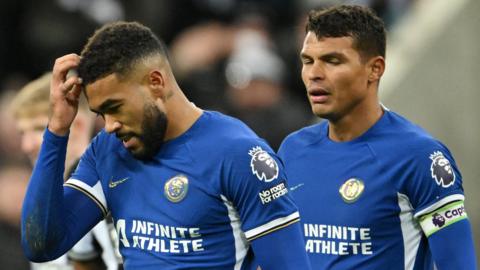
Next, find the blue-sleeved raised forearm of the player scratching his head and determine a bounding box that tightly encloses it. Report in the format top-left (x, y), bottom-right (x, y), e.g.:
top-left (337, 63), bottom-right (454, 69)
top-left (21, 131), bottom-right (68, 261)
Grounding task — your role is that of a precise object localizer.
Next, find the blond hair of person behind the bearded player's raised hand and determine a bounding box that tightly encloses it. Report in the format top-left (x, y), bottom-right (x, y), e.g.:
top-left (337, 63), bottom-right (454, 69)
top-left (9, 72), bottom-right (88, 119)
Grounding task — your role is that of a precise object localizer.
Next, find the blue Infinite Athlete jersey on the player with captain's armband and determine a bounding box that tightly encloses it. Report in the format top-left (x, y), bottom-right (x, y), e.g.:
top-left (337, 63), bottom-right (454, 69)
top-left (279, 108), bottom-right (464, 270)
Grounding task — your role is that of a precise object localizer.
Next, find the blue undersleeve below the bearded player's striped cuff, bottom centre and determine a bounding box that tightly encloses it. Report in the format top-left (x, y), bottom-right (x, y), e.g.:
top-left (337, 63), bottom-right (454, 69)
top-left (252, 222), bottom-right (311, 270)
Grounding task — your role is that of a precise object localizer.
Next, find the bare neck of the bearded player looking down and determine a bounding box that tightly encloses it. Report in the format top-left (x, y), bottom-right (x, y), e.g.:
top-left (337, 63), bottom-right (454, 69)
top-left (164, 89), bottom-right (203, 141)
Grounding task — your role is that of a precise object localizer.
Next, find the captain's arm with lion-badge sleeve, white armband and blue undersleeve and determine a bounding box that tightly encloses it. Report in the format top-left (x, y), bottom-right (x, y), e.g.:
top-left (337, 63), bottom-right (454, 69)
top-left (406, 142), bottom-right (475, 269)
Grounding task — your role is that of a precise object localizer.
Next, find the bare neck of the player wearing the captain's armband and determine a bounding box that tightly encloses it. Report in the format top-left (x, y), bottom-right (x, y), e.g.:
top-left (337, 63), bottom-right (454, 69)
top-left (328, 101), bottom-right (383, 142)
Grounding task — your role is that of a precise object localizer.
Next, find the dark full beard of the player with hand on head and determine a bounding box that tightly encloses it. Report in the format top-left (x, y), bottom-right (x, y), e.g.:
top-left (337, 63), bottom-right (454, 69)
top-left (132, 103), bottom-right (168, 160)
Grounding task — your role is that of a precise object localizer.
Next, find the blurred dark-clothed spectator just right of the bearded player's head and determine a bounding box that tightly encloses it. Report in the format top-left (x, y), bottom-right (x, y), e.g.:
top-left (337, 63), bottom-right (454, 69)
top-left (171, 22), bottom-right (235, 111)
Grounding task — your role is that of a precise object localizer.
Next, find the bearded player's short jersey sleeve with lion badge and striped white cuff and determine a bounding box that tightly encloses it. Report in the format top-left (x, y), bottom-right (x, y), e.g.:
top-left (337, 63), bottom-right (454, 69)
top-left (222, 140), bottom-right (299, 241)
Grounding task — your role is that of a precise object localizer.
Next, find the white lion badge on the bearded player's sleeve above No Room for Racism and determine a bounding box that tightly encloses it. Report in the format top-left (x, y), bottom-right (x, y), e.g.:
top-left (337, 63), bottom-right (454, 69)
top-left (248, 146), bottom-right (278, 183)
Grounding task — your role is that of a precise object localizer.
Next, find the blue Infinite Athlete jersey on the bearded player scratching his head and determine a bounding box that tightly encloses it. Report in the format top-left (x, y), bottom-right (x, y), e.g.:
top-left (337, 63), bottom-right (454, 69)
top-left (65, 111), bottom-right (299, 269)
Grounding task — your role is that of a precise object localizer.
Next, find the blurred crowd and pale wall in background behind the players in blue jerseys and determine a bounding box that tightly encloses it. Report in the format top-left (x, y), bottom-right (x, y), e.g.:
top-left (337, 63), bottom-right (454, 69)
top-left (0, 0), bottom-right (480, 270)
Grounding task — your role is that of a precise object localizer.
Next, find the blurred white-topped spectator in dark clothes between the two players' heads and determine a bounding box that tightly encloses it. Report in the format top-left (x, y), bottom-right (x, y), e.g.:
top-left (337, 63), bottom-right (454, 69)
top-left (225, 24), bottom-right (309, 149)
